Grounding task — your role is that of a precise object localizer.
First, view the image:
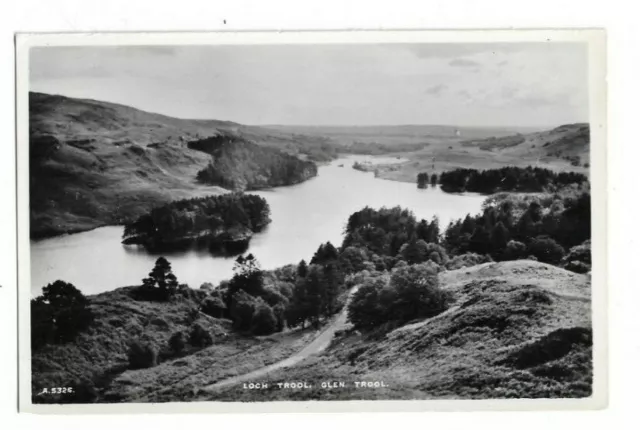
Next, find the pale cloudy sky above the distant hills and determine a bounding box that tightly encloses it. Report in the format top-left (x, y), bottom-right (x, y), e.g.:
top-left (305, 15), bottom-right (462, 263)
top-left (30, 42), bottom-right (589, 127)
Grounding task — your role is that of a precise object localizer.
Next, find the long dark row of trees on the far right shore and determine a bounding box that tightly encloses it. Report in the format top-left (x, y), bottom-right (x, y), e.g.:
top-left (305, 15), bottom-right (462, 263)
top-left (440, 166), bottom-right (588, 194)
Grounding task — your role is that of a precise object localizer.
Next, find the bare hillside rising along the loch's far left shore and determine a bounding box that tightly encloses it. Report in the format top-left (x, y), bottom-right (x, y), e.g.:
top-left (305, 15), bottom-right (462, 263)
top-left (29, 93), bottom-right (322, 238)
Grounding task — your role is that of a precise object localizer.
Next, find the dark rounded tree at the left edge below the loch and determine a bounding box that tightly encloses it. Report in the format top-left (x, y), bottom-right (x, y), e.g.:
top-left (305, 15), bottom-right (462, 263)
top-left (31, 281), bottom-right (94, 350)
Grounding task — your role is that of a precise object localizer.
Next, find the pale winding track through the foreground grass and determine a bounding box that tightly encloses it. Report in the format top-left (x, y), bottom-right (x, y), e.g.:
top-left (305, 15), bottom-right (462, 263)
top-left (200, 288), bottom-right (356, 392)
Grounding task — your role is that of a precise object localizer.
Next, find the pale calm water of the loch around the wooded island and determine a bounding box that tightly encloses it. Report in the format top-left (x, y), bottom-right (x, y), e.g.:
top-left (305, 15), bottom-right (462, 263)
top-left (31, 156), bottom-right (484, 294)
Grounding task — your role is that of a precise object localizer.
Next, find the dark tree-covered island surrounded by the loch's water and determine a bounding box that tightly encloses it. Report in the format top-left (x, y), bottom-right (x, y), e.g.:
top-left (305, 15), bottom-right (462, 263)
top-left (122, 193), bottom-right (271, 253)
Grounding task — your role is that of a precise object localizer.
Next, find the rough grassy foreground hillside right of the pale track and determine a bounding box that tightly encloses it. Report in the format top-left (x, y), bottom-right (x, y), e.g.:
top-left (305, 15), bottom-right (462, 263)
top-left (196, 260), bottom-right (592, 401)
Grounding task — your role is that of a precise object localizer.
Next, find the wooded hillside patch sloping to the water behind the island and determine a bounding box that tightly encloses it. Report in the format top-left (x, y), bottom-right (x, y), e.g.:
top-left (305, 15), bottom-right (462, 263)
top-left (189, 134), bottom-right (318, 190)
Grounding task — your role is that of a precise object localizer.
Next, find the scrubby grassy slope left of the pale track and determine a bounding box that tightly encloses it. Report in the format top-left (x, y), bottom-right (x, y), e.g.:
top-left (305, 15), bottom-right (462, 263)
top-left (32, 288), bottom-right (315, 402)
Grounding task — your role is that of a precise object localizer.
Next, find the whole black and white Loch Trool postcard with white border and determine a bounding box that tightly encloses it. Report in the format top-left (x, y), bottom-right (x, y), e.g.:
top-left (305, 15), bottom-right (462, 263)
top-left (17, 30), bottom-right (606, 411)
